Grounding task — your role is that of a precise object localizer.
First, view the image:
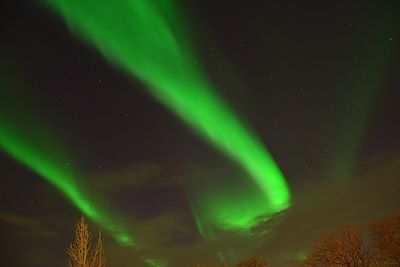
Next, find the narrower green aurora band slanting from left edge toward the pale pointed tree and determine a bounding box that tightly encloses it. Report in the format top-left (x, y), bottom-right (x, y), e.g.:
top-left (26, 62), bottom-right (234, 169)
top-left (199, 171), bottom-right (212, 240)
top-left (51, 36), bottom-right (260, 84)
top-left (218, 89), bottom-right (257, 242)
top-left (0, 75), bottom-right (134, 245)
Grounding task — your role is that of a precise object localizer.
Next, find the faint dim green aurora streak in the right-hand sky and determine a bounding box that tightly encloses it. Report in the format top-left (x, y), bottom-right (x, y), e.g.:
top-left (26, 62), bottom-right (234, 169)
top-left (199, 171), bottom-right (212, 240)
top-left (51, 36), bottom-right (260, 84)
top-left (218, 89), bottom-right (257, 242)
top-left (332, 7), bottom-right (400, 180)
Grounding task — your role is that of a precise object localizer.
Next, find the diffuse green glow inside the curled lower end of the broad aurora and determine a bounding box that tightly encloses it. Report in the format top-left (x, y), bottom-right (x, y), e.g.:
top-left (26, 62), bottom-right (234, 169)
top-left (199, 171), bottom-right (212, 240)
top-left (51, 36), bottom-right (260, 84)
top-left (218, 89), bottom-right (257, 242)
top-left (189, 171), bottom-right (282, 234)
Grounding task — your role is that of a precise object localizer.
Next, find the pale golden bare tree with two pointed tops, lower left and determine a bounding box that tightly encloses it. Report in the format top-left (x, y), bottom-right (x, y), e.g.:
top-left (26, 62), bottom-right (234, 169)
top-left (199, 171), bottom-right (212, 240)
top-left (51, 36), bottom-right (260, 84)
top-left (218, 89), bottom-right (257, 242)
top-left (67, 216), bottom-right (105, 267)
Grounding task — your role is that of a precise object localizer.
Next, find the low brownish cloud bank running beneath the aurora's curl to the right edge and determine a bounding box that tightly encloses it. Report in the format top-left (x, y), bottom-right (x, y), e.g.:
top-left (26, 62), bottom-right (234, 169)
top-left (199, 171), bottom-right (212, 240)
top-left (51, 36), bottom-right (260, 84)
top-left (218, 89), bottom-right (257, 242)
top-left (101, 157), bottom-right (400, 267)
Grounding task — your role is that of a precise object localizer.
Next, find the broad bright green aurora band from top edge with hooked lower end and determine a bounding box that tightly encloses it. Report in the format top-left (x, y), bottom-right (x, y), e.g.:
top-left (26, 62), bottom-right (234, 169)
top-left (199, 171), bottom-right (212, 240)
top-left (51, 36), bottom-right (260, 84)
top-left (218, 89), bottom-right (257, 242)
top-left (42, 0), bottom-right (290, 234)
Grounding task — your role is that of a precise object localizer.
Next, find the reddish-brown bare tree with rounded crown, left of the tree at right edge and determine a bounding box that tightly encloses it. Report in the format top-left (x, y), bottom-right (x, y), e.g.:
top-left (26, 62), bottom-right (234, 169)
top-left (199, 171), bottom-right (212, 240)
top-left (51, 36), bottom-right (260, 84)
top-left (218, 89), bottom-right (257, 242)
top-left (305, 226), bottom-right (373, 267)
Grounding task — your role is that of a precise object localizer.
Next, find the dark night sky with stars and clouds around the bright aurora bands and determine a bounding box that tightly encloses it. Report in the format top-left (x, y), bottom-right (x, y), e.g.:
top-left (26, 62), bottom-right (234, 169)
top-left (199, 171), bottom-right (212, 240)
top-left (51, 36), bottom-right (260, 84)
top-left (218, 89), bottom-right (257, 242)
top-left (0, 0), bottom-right (400, 267)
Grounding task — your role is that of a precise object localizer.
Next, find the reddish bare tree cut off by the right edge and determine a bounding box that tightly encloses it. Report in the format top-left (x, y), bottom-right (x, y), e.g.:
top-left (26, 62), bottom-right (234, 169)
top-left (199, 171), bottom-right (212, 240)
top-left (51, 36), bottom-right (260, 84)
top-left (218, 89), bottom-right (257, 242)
top-left (369, 210), bottom-right (400, 266)
